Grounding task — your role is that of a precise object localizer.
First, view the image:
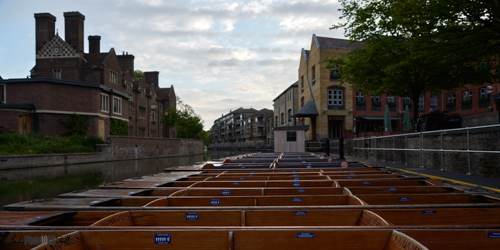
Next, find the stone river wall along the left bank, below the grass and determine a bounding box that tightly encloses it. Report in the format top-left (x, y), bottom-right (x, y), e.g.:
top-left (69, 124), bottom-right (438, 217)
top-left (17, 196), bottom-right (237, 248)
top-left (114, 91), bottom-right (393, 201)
top-left (0, 136), bottom-right (203, 170)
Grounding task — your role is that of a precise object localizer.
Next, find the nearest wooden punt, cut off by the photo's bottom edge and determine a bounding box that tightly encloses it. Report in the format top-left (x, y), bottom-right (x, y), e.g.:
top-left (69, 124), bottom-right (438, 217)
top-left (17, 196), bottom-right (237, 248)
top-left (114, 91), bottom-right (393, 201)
top-left (5, 228), bottom-right (500, 250)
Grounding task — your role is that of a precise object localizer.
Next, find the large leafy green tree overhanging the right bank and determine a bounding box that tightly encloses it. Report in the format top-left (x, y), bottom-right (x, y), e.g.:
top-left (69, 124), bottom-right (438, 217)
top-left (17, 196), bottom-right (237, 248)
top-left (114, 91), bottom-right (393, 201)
top-left (327, 0), bottom-right (498, 125)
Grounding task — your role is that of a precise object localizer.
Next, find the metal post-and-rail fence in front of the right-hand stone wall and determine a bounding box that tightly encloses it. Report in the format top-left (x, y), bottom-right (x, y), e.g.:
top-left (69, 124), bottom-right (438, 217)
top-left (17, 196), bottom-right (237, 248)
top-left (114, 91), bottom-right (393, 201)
top-left (330, 124), bottom-right (500, 175)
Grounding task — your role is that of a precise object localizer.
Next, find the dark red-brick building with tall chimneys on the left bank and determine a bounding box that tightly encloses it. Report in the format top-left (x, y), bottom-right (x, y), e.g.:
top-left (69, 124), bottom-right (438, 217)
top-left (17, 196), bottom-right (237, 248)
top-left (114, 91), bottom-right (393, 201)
top-left (0, 12), bottom-right (176, 138)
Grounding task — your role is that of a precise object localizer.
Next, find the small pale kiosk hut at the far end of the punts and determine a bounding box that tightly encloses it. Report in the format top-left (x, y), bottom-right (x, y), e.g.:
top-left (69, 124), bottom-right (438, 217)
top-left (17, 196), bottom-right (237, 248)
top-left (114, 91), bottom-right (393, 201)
top-left (274, 125), bottom-right (309, 152)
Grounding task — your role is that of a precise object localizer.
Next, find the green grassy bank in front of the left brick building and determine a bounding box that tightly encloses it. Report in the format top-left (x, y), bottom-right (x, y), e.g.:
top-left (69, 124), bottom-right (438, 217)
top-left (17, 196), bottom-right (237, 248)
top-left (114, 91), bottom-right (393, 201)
top-left (0, 133), bottom-right (104, 155)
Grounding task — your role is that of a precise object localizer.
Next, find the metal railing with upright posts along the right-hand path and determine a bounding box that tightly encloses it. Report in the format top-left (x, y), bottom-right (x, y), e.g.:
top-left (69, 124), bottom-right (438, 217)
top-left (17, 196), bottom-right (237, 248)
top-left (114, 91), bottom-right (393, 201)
top-left (340, 124), bottom-right (500, 175)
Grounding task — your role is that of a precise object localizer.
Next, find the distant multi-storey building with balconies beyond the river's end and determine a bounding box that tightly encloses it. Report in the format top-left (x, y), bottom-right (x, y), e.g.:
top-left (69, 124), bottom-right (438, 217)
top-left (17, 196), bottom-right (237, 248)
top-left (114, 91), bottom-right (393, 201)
top-left (211, 108), bottom-right (273, 148)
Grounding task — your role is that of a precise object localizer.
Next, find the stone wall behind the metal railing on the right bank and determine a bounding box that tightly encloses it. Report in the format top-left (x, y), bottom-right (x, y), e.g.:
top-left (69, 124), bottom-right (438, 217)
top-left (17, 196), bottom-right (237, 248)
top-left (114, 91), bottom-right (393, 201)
top-left (345, 127), bottom-right (500, 178)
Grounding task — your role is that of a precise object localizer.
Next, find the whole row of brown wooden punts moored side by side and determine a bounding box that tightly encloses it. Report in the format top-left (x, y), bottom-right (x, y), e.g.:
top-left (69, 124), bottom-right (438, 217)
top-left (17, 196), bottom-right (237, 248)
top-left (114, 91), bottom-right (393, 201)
top-left (0, 154), bottom-right (500, 249)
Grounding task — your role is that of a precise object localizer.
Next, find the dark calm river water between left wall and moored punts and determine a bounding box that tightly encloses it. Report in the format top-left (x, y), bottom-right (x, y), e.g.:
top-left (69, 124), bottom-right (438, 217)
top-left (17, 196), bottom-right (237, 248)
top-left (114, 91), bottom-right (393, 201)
top-left (0, 151), bottom-right (258, 210)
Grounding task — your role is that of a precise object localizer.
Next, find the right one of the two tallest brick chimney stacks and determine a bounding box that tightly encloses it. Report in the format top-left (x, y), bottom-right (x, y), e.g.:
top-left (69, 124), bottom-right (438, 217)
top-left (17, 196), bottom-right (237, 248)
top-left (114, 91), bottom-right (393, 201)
top-left (64, 11), bottom-right (85, 52)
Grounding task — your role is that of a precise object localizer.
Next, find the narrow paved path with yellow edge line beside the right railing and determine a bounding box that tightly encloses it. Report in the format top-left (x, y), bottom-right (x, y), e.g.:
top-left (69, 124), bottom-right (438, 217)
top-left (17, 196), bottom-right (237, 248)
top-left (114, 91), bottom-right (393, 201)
top-left (346, 156), bottom-right (500, 192)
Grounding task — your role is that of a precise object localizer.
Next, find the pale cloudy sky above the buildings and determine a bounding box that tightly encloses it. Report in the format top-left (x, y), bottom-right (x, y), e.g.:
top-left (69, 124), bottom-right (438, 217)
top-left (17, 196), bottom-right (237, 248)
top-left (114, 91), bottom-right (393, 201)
top-left (0, 0), bottom-right (344, 129)
